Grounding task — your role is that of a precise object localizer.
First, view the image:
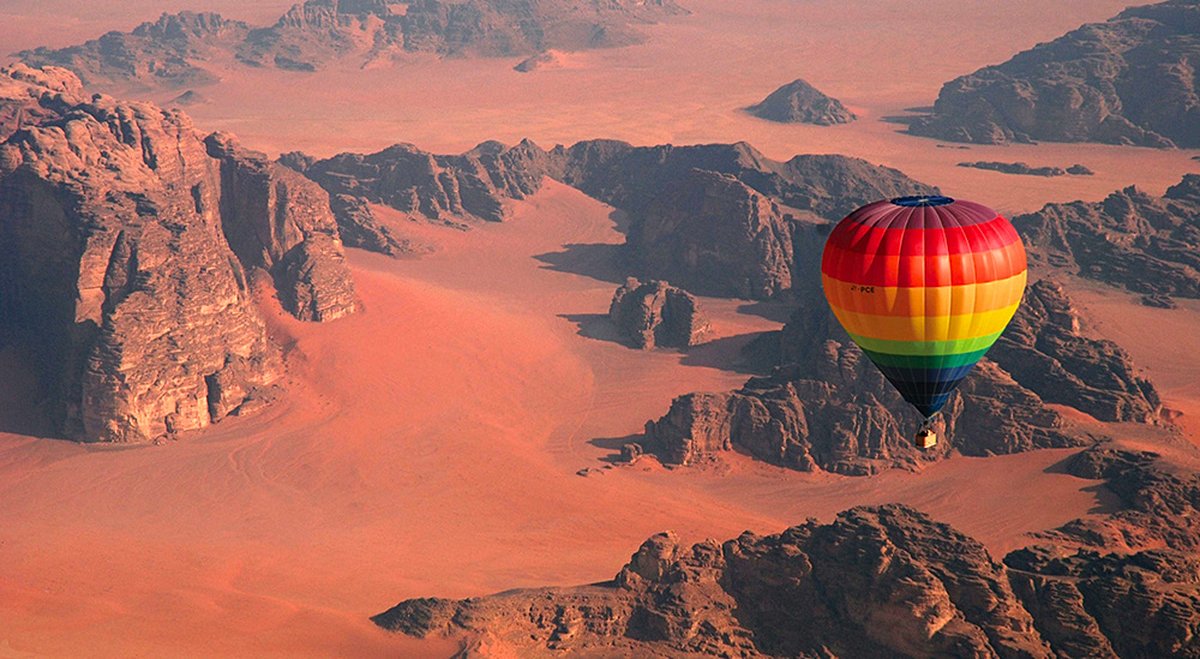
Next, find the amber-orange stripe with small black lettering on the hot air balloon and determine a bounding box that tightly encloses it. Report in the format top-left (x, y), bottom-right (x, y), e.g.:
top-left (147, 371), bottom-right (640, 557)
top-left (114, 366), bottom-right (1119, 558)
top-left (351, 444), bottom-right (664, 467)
top-left (821, 271), bottom-right (1026, 317)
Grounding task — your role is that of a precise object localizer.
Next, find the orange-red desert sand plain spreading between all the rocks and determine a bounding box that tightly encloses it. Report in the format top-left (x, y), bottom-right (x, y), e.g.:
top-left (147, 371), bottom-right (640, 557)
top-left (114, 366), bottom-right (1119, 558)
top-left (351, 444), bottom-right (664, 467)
top-left (0, 0), bottom-right (1200, 657)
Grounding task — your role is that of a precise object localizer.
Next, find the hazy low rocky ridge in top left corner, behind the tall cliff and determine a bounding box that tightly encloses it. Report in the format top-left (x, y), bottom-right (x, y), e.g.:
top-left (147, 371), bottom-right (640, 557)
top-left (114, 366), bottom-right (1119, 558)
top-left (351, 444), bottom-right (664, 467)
top-left (18, 12), bottom-right (250, 88)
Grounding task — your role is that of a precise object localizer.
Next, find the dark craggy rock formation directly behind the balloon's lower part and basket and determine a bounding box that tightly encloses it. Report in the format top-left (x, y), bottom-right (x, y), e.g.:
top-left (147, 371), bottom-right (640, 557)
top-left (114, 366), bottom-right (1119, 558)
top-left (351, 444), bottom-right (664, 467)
top-left (642, 270), bottom-right (1160, 475)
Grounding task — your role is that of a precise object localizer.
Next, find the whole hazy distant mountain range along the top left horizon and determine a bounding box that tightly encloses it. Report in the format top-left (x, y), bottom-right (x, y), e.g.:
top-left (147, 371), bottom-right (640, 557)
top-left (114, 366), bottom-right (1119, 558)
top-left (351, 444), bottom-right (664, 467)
top-left (19, 0), bottom-right (686, 88)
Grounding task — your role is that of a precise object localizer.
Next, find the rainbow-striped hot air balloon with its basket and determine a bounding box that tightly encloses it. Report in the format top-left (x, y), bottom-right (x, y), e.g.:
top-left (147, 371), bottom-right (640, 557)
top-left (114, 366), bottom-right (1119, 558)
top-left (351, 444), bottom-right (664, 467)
top-left (821, 196), bottom-right (1025, 448)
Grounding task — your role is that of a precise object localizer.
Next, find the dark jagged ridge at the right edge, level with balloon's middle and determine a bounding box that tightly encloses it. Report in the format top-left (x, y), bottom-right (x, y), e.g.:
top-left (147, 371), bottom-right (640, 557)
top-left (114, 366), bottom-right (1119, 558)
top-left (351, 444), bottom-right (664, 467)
top-left (1013, 174), bottom-right (1200, 298)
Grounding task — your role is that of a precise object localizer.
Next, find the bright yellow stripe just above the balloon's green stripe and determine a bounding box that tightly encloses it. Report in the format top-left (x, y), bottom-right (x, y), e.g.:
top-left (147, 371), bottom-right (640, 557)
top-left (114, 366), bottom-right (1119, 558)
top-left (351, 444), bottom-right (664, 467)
top-left (833, 301), bottom-right (1020, 341)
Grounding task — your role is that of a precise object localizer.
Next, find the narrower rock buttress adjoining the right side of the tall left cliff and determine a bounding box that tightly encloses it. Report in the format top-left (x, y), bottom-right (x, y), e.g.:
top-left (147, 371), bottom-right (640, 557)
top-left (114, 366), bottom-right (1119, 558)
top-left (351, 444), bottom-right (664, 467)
top-left (205, 133), bottom-right (355, 320)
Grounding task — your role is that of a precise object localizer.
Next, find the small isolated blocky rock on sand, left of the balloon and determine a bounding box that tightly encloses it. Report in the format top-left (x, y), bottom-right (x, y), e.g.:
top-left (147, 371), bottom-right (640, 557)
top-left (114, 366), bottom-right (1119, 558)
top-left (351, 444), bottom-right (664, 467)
top-left (608, 278), bottom-right (713, 351)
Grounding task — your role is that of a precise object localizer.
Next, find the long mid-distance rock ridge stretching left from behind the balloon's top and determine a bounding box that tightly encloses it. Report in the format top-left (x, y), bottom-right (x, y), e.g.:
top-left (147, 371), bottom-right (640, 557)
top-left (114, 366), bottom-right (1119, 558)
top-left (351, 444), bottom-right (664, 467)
top-left (281, 139), bottom-right (936, 298)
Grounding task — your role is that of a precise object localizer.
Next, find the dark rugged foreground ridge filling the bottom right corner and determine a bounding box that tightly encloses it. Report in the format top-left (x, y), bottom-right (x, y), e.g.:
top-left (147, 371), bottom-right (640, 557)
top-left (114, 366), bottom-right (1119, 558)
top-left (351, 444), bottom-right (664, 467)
top-left (372, 447), bottom-right (1200, 658)
